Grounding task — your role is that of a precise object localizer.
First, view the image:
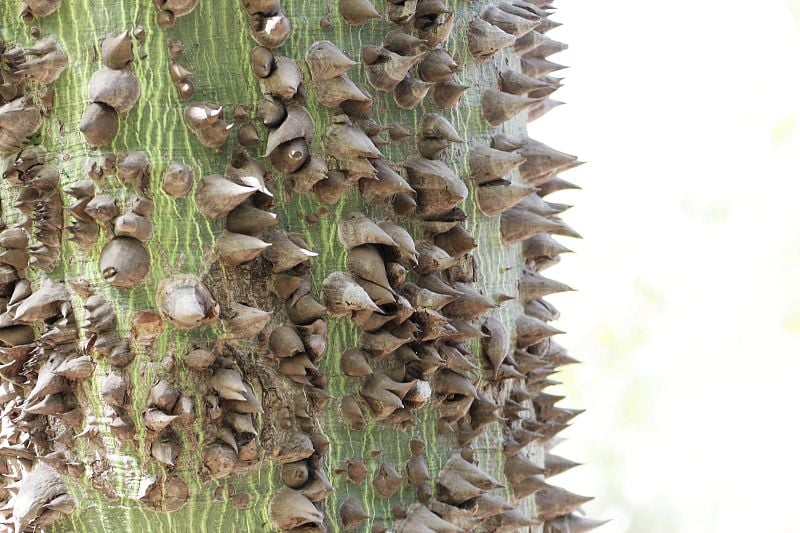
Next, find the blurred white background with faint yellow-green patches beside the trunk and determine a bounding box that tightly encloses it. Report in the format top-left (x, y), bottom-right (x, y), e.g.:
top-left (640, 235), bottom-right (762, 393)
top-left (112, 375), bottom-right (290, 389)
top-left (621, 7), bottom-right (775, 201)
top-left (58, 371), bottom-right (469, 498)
top-left (531, 0), bottom-right (800, 533)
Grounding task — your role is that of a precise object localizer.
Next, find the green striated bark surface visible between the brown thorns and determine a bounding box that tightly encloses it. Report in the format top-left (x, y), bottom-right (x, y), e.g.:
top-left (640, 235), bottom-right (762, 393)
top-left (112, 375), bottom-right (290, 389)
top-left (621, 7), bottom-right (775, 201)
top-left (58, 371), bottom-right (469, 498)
top-left (0, 0), bottom-right (588, 532)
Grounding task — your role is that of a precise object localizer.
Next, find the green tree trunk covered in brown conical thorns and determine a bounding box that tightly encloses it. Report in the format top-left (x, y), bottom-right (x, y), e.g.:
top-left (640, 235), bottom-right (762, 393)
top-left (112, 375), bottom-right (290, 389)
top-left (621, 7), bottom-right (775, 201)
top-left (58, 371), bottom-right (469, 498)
top-left (0, 0), bottom-right (598, 533)
